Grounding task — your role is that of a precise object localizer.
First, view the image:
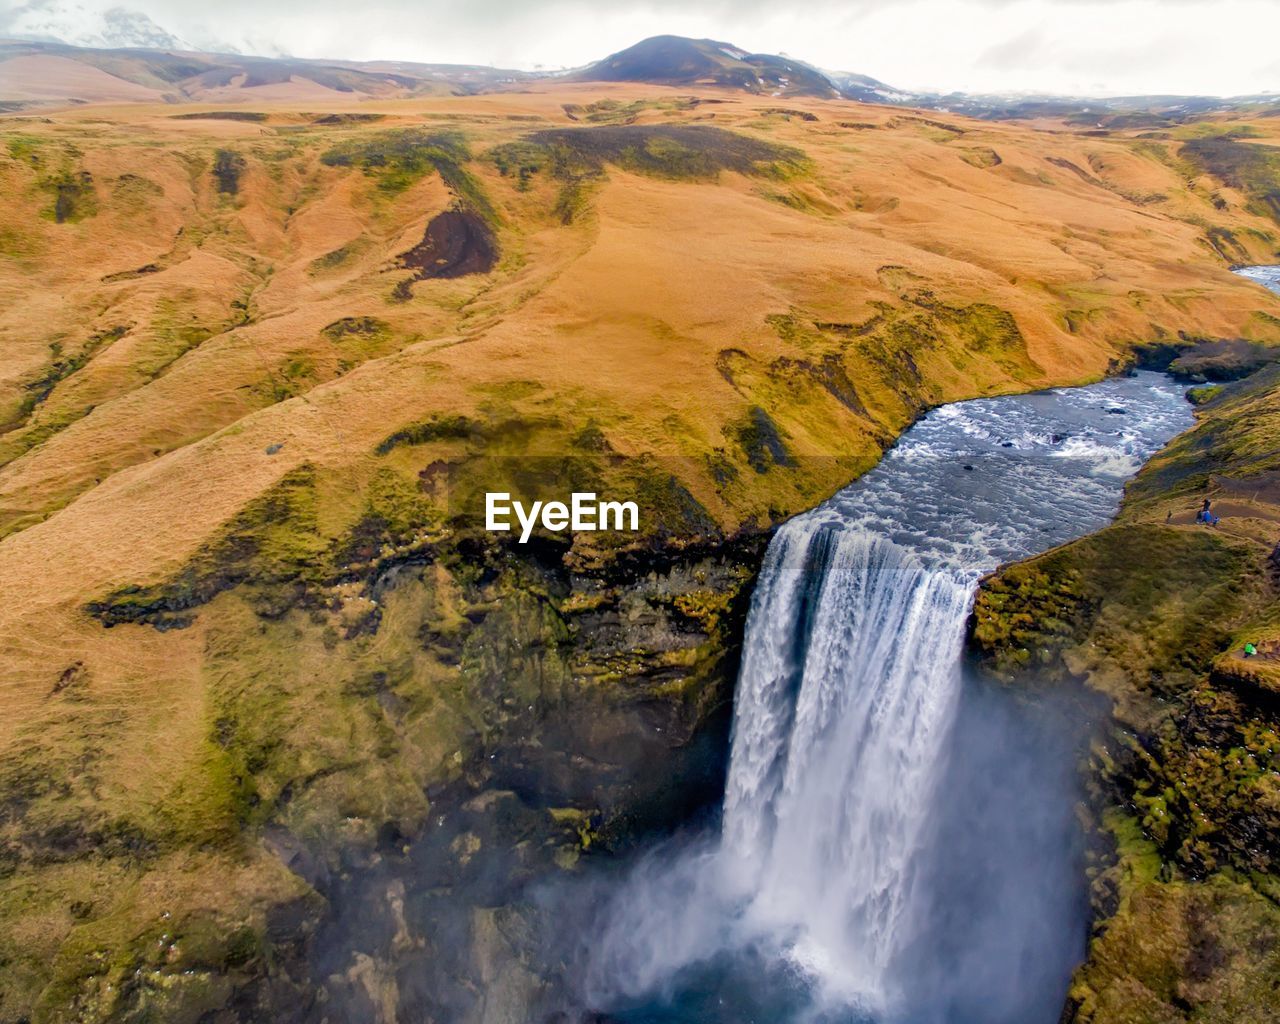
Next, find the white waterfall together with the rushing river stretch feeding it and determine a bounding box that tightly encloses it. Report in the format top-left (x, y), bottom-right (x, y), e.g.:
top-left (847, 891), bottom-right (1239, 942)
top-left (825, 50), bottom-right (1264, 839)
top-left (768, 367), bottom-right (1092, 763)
top-left (590, 374), bottom-right (1190, 1020)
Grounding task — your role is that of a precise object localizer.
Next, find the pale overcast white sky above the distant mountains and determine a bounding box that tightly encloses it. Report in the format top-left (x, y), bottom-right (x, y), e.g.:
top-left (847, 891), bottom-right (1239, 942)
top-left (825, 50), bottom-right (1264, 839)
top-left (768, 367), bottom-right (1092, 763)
top-left (0, 0), bottom-right (1280, 96)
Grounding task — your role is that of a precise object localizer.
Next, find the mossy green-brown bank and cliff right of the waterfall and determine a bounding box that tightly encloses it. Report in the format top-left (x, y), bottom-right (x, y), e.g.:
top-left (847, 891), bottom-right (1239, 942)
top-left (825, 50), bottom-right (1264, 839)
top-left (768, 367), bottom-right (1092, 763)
top-left (972, 366), bottom-right (1280, 1024)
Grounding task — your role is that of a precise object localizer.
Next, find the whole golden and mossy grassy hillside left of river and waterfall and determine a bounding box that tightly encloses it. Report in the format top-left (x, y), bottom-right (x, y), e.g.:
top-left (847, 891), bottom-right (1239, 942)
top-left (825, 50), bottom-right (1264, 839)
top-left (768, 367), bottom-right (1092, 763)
top-left (0, 84), bottom-right (1280, 1021)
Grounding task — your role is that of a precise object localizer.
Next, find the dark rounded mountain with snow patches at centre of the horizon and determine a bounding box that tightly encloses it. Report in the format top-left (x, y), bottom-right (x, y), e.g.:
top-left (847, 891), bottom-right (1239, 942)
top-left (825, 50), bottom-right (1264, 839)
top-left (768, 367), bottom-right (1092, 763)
top-left (568, 36), bottom-right (838, 97)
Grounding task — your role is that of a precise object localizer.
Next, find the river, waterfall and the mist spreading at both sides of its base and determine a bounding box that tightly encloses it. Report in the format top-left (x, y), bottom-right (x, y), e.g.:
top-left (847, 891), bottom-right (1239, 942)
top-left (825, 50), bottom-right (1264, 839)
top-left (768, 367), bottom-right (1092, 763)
top-left (585, 372), bottom-right (1192, 1024)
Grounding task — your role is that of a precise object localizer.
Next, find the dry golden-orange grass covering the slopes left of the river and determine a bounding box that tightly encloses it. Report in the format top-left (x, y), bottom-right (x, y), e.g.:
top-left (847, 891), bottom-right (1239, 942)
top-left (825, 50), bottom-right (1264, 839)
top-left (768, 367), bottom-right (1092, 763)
top-left (0, 83), bottom-right (1280, 1018)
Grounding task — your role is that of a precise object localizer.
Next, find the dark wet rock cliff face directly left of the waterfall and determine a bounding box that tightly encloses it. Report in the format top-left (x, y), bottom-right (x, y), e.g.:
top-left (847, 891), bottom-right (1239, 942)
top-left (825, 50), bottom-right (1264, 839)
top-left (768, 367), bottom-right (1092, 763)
top-left (248, 538), bottom-right (765, 1024)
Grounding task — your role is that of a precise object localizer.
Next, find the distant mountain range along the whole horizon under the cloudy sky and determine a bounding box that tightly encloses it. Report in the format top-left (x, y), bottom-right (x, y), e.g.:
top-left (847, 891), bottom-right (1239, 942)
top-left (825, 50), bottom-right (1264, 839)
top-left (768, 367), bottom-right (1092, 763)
top-left (0, 27), bottom-right (1280, 122)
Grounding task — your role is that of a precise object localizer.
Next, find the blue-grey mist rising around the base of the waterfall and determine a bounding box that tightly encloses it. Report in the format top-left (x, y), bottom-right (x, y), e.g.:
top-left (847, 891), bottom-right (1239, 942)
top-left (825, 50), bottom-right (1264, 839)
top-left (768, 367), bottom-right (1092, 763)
top-left (538, 677), bottom-right (1088, 1024)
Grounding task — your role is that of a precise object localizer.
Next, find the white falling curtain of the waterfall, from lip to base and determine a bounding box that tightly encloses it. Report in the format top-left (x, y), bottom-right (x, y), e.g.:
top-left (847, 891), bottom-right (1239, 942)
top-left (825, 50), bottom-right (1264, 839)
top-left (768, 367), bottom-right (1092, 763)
top-left (722, 518), bottom-right (972, 1005)
